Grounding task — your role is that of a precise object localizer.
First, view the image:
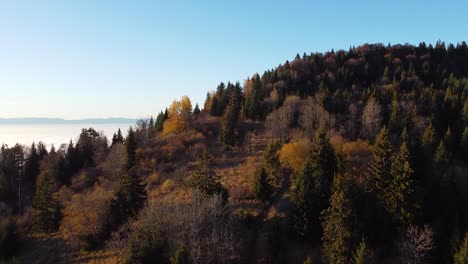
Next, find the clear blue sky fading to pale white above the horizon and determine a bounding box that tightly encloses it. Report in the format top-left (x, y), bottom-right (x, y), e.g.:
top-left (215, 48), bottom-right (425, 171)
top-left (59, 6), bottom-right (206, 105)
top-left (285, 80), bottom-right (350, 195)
top-left (0, 0), bottom-right (468, 119)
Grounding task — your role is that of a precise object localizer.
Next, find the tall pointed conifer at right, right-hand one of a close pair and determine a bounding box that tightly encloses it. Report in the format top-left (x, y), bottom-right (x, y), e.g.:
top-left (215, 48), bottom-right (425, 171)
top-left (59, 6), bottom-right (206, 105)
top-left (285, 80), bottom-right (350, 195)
top-left (390, 142), bottom-right (414, 228)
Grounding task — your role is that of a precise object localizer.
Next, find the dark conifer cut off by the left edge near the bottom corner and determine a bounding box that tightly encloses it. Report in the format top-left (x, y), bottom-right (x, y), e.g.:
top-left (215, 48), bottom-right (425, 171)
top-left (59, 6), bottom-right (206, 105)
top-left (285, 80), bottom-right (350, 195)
top-left (0, 214), bottom-right (19, 262)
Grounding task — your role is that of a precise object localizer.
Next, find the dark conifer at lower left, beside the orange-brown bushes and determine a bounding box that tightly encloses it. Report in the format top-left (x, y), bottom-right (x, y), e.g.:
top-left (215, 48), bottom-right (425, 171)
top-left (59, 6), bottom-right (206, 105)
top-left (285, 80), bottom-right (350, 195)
top-left (32, 173), bottom-right (61, 233)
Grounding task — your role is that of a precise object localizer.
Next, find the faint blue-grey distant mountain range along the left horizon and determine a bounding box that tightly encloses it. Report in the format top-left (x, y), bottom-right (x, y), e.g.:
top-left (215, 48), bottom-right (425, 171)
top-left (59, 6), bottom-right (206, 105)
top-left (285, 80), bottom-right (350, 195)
top-left (0, 117), bottom-right (138, 125)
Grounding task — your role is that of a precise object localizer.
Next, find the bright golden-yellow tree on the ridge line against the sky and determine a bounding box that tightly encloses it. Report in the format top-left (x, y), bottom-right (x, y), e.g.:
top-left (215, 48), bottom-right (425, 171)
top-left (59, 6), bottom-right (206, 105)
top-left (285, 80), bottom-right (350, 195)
top-left (163, 96), bottom-right (192, 135)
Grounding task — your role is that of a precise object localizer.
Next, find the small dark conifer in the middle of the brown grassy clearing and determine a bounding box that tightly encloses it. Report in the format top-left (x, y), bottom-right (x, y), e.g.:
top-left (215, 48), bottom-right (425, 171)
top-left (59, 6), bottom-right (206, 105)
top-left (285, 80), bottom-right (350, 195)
top-left (192, 148), bottom-right (228, 200)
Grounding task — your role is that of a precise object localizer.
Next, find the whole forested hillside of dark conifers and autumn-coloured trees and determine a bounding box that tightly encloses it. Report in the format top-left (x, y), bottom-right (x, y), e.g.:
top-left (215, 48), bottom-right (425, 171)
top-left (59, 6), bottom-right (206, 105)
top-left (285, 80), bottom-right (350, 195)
top-left (0, 41), bottom-right (468, 264)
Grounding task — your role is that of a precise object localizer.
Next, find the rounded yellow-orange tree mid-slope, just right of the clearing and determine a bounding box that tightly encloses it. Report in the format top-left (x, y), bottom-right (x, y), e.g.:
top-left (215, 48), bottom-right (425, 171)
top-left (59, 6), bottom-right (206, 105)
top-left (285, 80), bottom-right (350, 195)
top-left (279, 140), bottom-right (311, 172)
